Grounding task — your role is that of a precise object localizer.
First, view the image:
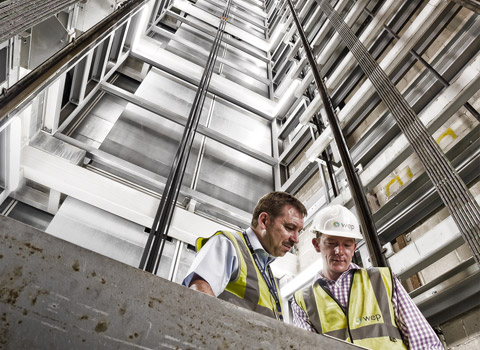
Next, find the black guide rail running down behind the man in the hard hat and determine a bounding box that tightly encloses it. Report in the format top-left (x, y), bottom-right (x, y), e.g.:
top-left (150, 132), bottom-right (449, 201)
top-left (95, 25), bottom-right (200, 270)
top-left (287, 0), bottom-right (387, 267)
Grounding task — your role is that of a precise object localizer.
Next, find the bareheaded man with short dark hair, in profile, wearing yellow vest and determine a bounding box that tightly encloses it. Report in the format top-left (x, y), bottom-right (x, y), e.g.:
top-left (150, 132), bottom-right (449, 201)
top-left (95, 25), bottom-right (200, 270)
top-left (183, 192), bottom-right (307, 320)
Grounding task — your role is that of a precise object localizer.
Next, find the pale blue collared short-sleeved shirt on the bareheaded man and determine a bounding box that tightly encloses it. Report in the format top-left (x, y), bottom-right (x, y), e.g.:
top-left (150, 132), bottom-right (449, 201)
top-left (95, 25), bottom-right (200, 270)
top-left (182, 227), bottom-right (275, 296)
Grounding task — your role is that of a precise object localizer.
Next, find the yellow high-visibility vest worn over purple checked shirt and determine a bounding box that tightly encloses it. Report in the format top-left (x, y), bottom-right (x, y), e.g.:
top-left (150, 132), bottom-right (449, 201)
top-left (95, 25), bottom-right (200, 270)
top-left (295, 268), bottom-right (407, 350)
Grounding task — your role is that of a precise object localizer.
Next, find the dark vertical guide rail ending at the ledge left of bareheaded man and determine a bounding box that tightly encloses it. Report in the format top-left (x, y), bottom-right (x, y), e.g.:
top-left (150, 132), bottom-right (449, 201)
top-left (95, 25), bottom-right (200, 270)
top-left (140, 0), bottom-right (231, 274)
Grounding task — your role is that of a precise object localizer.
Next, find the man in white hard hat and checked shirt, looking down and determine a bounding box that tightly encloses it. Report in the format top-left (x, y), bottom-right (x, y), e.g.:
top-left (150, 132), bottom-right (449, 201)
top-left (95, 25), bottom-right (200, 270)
top-left (292, 205), bottom-right (443, 349)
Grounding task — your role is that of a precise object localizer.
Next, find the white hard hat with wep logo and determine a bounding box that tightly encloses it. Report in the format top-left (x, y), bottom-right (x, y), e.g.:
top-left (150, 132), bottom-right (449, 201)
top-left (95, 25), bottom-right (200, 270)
top-left (310, 204), bottom-right (363, 239)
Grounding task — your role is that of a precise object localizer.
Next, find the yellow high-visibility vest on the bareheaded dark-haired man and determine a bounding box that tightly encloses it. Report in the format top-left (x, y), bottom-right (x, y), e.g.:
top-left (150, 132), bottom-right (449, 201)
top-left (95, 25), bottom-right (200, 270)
top-left (196, 231), bottom-right (283, 318)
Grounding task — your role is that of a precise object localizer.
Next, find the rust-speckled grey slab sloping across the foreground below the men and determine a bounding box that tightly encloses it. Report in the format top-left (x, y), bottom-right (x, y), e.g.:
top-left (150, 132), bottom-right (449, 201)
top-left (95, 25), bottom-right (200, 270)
top-left (0, 216), bottom-right (357, 350)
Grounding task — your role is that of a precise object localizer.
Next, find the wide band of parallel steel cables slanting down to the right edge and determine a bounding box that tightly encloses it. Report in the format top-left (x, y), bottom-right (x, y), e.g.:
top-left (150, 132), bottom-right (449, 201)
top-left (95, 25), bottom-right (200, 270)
top-left (316, 0), bottom-right (480, 265)
